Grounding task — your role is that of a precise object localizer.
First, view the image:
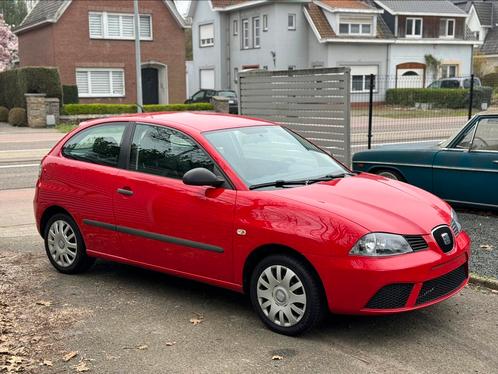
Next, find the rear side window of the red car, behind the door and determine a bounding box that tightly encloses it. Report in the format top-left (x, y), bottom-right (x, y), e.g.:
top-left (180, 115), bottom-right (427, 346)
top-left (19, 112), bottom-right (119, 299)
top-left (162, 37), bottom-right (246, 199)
top-left (62, 123), bottom-right (126, 166)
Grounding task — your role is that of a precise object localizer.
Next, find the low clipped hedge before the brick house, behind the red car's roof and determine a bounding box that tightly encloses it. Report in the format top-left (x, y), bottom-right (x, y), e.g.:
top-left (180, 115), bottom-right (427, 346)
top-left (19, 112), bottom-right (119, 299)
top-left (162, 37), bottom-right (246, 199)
top-left (63, 103), bottom-right (213, 115)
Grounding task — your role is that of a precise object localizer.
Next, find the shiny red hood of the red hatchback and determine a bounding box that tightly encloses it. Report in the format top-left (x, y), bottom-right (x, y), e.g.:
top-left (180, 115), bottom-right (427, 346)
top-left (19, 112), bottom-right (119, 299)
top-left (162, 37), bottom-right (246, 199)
top-left (269, 174), bottom-right (451, 235)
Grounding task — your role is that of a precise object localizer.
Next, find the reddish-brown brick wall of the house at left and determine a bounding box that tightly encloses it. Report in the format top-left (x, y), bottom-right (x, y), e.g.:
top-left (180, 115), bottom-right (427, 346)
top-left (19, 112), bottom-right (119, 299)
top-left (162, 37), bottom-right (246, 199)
top-left (20, 0), bottom-right (185, 103)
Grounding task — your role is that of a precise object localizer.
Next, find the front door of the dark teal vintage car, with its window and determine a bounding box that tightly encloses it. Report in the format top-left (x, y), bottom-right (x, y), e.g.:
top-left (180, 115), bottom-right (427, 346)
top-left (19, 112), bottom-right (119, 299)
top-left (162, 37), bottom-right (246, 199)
top-left (433, 117), bottom-right (498, 206)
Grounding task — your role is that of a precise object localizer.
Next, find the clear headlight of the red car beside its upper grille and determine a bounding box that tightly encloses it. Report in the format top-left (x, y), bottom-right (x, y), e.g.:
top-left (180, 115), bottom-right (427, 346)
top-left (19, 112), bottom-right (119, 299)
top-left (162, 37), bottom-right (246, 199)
top-left (349, 232), bottom-right (413, 257)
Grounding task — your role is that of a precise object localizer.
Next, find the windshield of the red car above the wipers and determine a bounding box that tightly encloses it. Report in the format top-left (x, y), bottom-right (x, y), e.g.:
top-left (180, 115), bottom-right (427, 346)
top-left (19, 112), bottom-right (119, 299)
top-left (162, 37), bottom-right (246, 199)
top-left (204, 126), bottom-right (348, 186)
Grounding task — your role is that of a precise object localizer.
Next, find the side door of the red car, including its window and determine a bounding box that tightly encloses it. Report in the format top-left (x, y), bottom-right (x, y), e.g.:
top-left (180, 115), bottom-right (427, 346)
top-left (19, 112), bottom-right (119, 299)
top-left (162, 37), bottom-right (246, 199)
top-left (114, 124), bottom-right (236, 282)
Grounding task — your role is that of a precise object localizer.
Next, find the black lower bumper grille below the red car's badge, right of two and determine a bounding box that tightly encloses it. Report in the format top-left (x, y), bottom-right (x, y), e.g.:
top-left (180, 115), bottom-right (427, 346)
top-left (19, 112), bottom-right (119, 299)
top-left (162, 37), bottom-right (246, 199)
top-left (417, 264), bottom-right (468, 305)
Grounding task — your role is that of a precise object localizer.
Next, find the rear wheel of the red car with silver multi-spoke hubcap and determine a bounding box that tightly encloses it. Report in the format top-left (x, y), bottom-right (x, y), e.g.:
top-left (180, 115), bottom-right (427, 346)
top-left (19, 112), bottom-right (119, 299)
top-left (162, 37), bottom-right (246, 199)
top-left (43, 213), bottom-right (95, 274)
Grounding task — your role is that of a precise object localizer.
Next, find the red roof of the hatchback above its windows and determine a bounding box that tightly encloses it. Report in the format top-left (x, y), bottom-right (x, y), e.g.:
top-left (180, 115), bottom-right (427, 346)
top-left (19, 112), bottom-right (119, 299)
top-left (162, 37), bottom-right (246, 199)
top-left (81, 112), bottom-right (275, 132)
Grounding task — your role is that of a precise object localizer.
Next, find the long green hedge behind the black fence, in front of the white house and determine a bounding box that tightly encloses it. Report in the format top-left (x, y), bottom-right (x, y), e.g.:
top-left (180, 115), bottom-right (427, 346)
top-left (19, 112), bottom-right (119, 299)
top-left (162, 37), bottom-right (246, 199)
top-left (386, 87), bottom-right (493, 109)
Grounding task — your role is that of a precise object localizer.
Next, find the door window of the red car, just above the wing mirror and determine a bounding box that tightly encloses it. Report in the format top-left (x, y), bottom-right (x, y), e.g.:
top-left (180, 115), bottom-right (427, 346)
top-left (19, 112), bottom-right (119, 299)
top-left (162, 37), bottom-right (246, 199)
top-left (130, 125), bottom-right (215, 179)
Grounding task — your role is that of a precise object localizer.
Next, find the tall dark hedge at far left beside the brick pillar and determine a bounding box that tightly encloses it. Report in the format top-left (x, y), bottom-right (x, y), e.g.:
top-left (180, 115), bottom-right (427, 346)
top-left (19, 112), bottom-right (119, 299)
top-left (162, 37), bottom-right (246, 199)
top-left (0, 67), bottom-right (62, 108)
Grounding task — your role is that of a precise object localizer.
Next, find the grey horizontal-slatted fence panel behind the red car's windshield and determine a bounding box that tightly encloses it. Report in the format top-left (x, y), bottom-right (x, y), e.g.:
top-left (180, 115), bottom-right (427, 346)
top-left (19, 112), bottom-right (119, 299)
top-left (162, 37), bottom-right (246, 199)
top-left (239, 67), bottom-right (351, 166)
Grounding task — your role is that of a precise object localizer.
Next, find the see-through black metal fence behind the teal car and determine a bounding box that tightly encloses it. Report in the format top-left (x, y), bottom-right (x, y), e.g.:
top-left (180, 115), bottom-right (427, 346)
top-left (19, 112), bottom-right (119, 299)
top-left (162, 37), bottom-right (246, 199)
top-left (350, 75), bottom-right (498, 153)
